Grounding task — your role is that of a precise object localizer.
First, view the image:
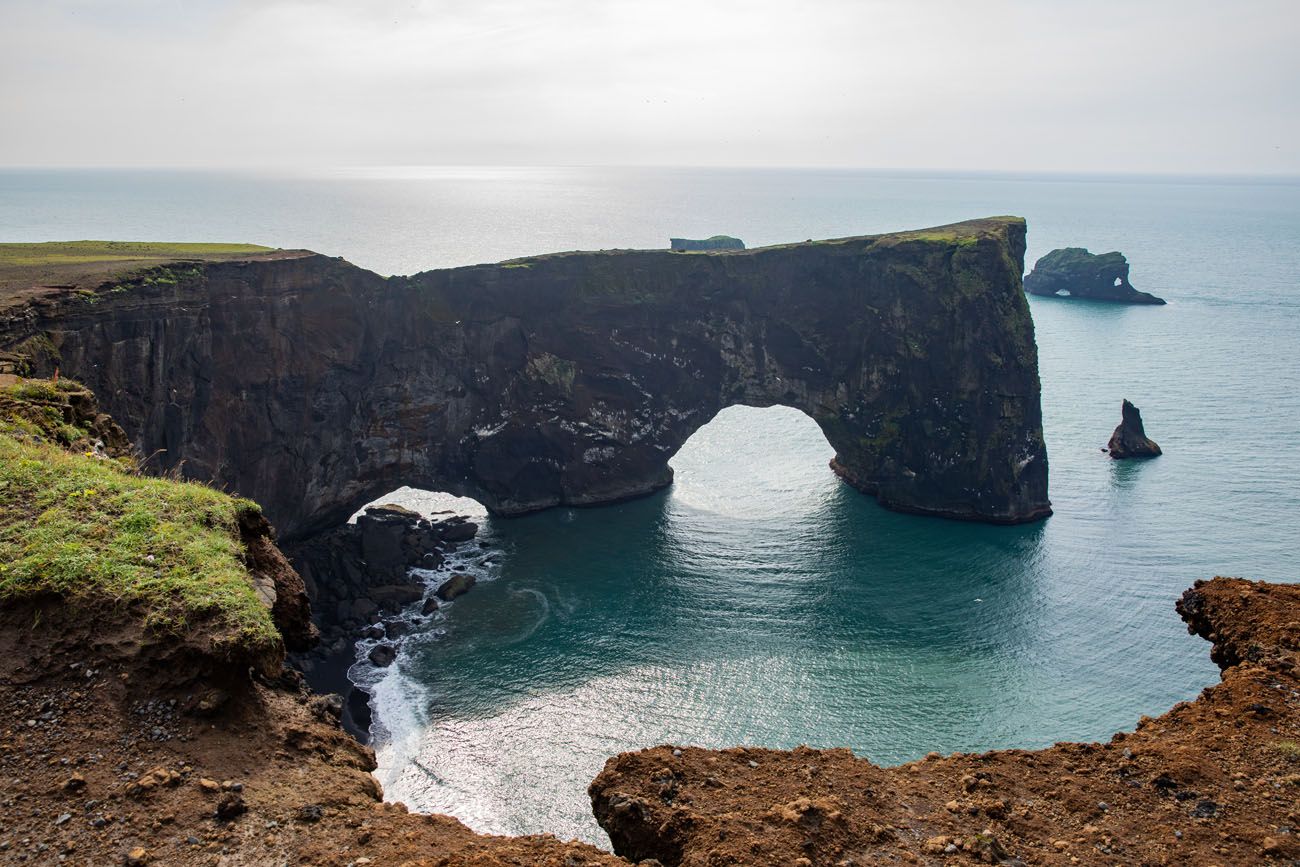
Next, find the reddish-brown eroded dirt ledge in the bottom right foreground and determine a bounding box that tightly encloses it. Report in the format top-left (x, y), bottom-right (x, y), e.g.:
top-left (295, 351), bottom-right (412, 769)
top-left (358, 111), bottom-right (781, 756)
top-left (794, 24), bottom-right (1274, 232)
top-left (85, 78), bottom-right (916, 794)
top-left (590, 578), bottom-right (1300, 867)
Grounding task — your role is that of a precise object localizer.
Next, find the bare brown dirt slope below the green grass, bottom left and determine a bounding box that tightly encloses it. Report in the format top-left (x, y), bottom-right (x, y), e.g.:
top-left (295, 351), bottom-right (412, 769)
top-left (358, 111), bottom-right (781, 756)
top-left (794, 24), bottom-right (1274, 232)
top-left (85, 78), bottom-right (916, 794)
top-left (0, 599), bottom-right (624, 867)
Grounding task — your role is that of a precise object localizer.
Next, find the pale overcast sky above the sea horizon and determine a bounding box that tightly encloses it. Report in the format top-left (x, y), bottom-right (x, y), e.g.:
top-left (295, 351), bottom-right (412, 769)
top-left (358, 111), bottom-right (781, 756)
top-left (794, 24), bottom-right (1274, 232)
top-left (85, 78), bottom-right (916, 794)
top-left (0, 0), bottom-right (1300, 174)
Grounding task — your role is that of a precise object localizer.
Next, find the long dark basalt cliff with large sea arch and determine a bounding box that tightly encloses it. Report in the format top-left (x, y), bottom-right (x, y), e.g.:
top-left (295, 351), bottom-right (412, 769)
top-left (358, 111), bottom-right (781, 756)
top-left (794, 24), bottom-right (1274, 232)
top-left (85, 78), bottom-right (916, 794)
top-left (0, 217), bottom-right (1050, 537)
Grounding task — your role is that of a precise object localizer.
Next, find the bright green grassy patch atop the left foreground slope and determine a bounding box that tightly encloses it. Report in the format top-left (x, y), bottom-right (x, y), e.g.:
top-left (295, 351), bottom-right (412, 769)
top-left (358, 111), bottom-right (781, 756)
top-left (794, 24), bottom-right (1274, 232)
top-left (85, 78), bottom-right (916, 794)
top-left (0, 381), bottom-right (277, 642)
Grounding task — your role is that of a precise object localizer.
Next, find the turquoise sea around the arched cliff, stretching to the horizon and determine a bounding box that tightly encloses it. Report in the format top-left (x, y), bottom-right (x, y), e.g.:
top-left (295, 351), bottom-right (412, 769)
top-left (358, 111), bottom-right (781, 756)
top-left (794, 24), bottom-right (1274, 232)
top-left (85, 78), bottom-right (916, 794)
top-left (0, 169), bottom-right (1300, 841)
